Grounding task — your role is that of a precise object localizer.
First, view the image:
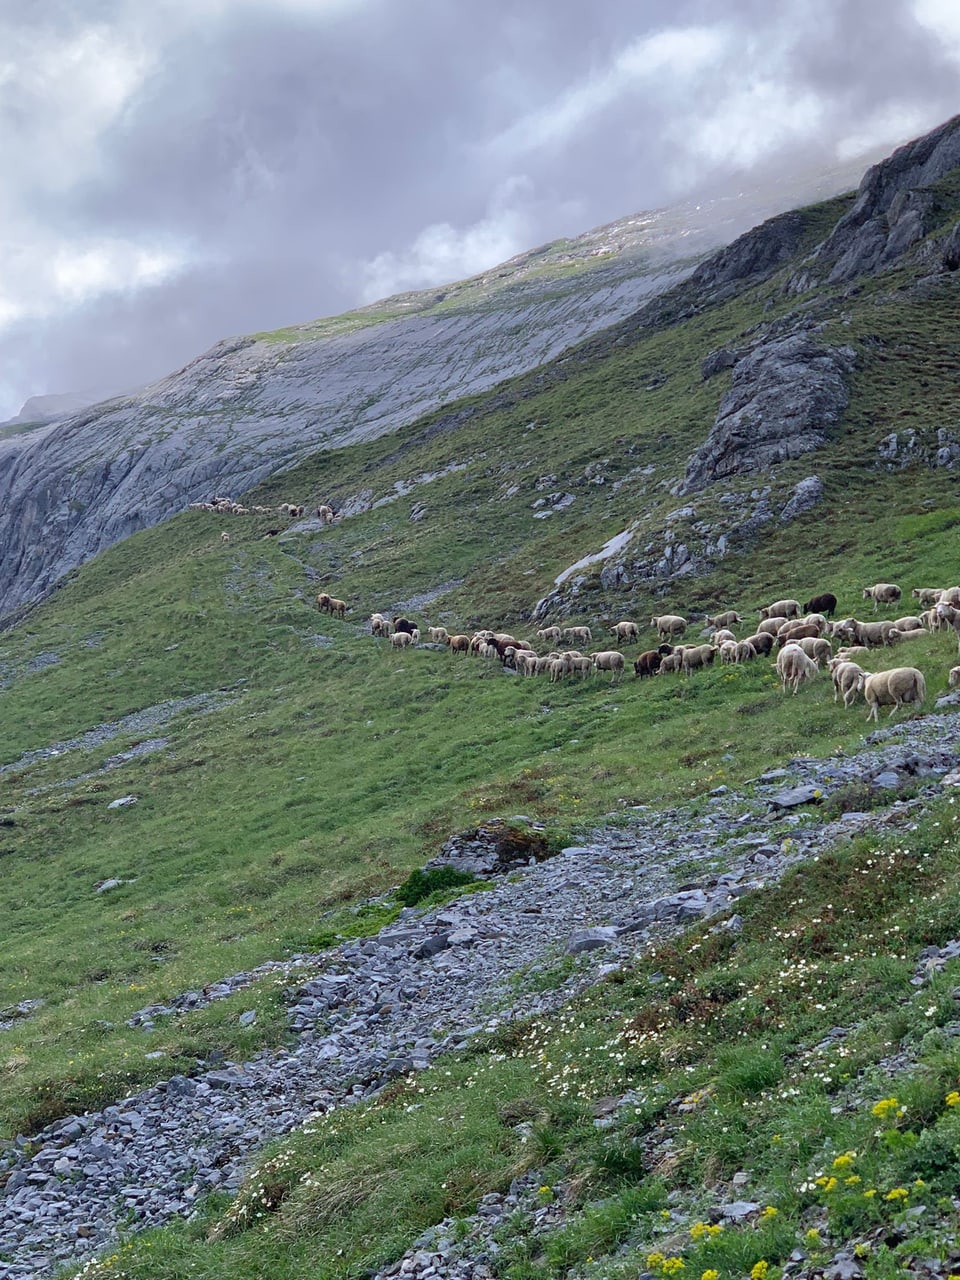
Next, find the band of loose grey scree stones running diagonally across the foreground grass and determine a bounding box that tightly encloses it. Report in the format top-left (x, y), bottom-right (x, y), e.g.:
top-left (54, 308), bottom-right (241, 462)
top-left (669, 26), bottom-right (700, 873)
top-left (0, 708), bottom-right (960, 1280)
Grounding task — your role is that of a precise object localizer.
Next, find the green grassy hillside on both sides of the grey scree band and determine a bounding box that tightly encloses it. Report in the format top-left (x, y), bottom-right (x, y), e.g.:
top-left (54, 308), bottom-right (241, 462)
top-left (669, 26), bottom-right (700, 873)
top-left (0, 175), bottom-right (960, 1280)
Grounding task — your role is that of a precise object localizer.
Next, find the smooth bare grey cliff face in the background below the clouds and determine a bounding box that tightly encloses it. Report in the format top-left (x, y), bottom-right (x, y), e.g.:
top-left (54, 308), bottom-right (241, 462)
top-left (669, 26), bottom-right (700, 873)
top-left (0, 259), bottom-right (689, 613)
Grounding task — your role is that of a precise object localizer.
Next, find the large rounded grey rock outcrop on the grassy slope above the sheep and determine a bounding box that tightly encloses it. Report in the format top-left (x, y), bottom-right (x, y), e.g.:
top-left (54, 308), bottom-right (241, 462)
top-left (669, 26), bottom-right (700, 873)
top-left (680, 332), bottom-right (855, 493)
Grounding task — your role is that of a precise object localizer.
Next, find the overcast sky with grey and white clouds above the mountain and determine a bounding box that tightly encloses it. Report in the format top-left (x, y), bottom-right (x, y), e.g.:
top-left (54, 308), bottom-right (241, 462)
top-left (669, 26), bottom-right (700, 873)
top-left (0, 0), bottom-right (960, 419)
